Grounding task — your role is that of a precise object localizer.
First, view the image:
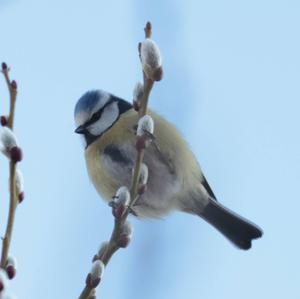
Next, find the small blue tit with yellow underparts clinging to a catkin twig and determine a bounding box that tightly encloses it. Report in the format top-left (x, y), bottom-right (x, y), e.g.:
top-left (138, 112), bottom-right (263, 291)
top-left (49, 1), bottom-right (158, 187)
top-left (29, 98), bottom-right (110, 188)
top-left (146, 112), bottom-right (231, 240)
top-left (75, 90), bottom-right (262, 250)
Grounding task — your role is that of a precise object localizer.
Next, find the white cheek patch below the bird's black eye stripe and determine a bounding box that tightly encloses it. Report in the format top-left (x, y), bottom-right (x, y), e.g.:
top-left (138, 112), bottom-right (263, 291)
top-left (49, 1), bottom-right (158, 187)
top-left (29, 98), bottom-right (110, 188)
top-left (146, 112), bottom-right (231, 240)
top-left (88, 102), bottom-right (119, 136)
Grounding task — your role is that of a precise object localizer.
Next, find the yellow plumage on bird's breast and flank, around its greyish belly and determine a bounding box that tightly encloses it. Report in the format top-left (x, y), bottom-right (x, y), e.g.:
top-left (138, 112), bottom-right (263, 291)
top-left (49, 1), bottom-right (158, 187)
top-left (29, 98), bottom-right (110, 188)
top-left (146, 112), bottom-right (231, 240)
top-left (85, 110), bottom-right (202, 201)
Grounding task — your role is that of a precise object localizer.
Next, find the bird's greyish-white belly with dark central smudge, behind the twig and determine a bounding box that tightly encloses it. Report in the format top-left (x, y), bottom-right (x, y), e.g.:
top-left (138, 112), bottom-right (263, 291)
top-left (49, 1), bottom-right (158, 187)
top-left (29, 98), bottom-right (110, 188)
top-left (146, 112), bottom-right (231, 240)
top-left (96, 145), bottom-right (182, 217)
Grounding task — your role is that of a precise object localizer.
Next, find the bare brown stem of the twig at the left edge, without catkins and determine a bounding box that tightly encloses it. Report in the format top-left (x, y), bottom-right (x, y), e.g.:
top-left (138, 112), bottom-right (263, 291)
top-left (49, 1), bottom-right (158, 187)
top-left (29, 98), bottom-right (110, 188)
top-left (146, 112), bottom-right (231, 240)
top-left (0, 64), bottom-right (18, 269)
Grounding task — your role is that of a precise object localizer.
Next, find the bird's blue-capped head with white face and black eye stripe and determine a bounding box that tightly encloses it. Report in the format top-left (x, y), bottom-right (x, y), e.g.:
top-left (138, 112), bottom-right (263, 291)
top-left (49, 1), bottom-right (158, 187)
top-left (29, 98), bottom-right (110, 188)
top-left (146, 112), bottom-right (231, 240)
top-left (74, 90), bottom-right (132, 146)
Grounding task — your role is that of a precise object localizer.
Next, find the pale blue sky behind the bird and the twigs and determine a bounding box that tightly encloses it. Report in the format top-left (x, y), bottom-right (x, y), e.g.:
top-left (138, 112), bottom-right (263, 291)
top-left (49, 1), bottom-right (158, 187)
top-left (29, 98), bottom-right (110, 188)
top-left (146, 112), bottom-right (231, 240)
top-left (0, 0), bottom-right (300, 299)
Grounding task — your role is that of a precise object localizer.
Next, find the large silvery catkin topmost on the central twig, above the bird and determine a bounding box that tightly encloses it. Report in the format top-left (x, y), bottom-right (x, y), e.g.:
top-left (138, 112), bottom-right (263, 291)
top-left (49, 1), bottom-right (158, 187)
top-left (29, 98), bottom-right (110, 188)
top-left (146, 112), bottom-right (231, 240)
top-left (140, 38), bottom-right (162, 81)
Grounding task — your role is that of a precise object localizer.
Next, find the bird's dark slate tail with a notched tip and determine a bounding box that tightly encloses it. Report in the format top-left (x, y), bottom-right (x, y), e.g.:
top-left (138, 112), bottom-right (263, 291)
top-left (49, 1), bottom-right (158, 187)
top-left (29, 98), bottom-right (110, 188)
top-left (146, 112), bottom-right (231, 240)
top-left (200, 200), bottom-right (262, 250)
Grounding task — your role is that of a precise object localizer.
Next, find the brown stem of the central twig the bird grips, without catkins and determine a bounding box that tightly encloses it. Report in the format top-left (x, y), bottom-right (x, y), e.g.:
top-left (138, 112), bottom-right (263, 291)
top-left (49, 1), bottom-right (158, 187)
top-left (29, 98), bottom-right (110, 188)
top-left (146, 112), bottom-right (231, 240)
top-left (79, 22), bottom-right (159, 299)
